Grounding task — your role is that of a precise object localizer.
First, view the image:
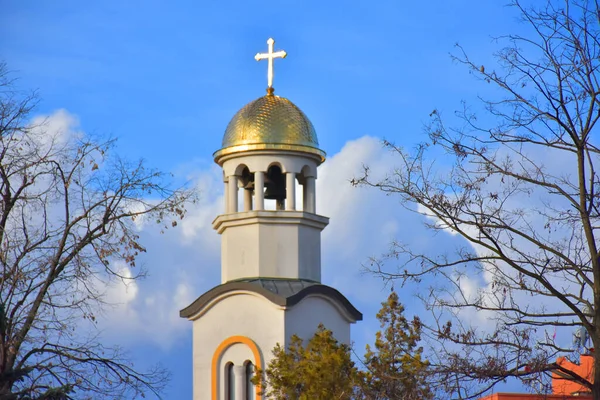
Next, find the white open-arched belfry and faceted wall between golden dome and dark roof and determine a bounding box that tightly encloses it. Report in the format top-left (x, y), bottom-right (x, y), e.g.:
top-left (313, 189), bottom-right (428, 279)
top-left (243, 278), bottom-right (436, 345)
top-left (213, 150), bottom-right (329, 282)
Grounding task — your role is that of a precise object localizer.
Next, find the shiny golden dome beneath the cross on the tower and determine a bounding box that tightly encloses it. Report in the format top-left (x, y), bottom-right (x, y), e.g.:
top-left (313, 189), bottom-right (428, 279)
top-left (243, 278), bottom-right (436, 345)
top-left (214, 94), bottom-right (325, 162)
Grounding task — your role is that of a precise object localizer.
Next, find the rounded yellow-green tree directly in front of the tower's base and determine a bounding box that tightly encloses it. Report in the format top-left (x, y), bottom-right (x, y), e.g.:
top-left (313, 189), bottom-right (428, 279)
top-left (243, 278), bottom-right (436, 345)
top-left (254, 325), bottom-right (358, 400)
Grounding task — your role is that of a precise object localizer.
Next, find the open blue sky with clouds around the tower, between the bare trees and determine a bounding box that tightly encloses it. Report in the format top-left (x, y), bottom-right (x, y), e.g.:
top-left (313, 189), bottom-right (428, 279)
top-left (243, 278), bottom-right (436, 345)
top-left (0, 0), bottom-right (536, 399)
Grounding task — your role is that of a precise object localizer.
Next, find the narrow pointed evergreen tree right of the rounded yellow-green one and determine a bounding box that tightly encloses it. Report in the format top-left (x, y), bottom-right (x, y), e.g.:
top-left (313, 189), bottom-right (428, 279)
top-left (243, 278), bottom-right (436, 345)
top-left (360, 291), bottom-right (433, 400)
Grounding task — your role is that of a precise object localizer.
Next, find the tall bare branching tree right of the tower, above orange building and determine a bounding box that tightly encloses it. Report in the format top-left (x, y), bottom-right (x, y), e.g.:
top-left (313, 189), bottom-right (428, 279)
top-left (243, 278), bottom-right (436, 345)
top-left (354, 0), bottom-right (600, 399)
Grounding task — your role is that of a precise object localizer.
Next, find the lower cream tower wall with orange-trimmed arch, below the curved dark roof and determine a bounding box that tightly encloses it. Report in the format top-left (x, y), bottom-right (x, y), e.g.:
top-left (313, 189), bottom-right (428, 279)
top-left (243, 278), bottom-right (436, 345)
top-left (190, 292), bottom-right (355, 400)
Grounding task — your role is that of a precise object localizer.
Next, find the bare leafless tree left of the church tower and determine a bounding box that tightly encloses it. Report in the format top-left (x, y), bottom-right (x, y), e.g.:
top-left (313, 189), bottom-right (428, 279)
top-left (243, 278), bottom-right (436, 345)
top-left (0, 64), bottom-right (192, 399)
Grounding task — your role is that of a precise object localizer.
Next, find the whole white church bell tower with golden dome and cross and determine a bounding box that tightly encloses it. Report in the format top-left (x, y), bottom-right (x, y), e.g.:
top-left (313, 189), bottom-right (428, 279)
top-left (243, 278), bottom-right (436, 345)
top-left (180, 39), bottom-right (362, 400)
